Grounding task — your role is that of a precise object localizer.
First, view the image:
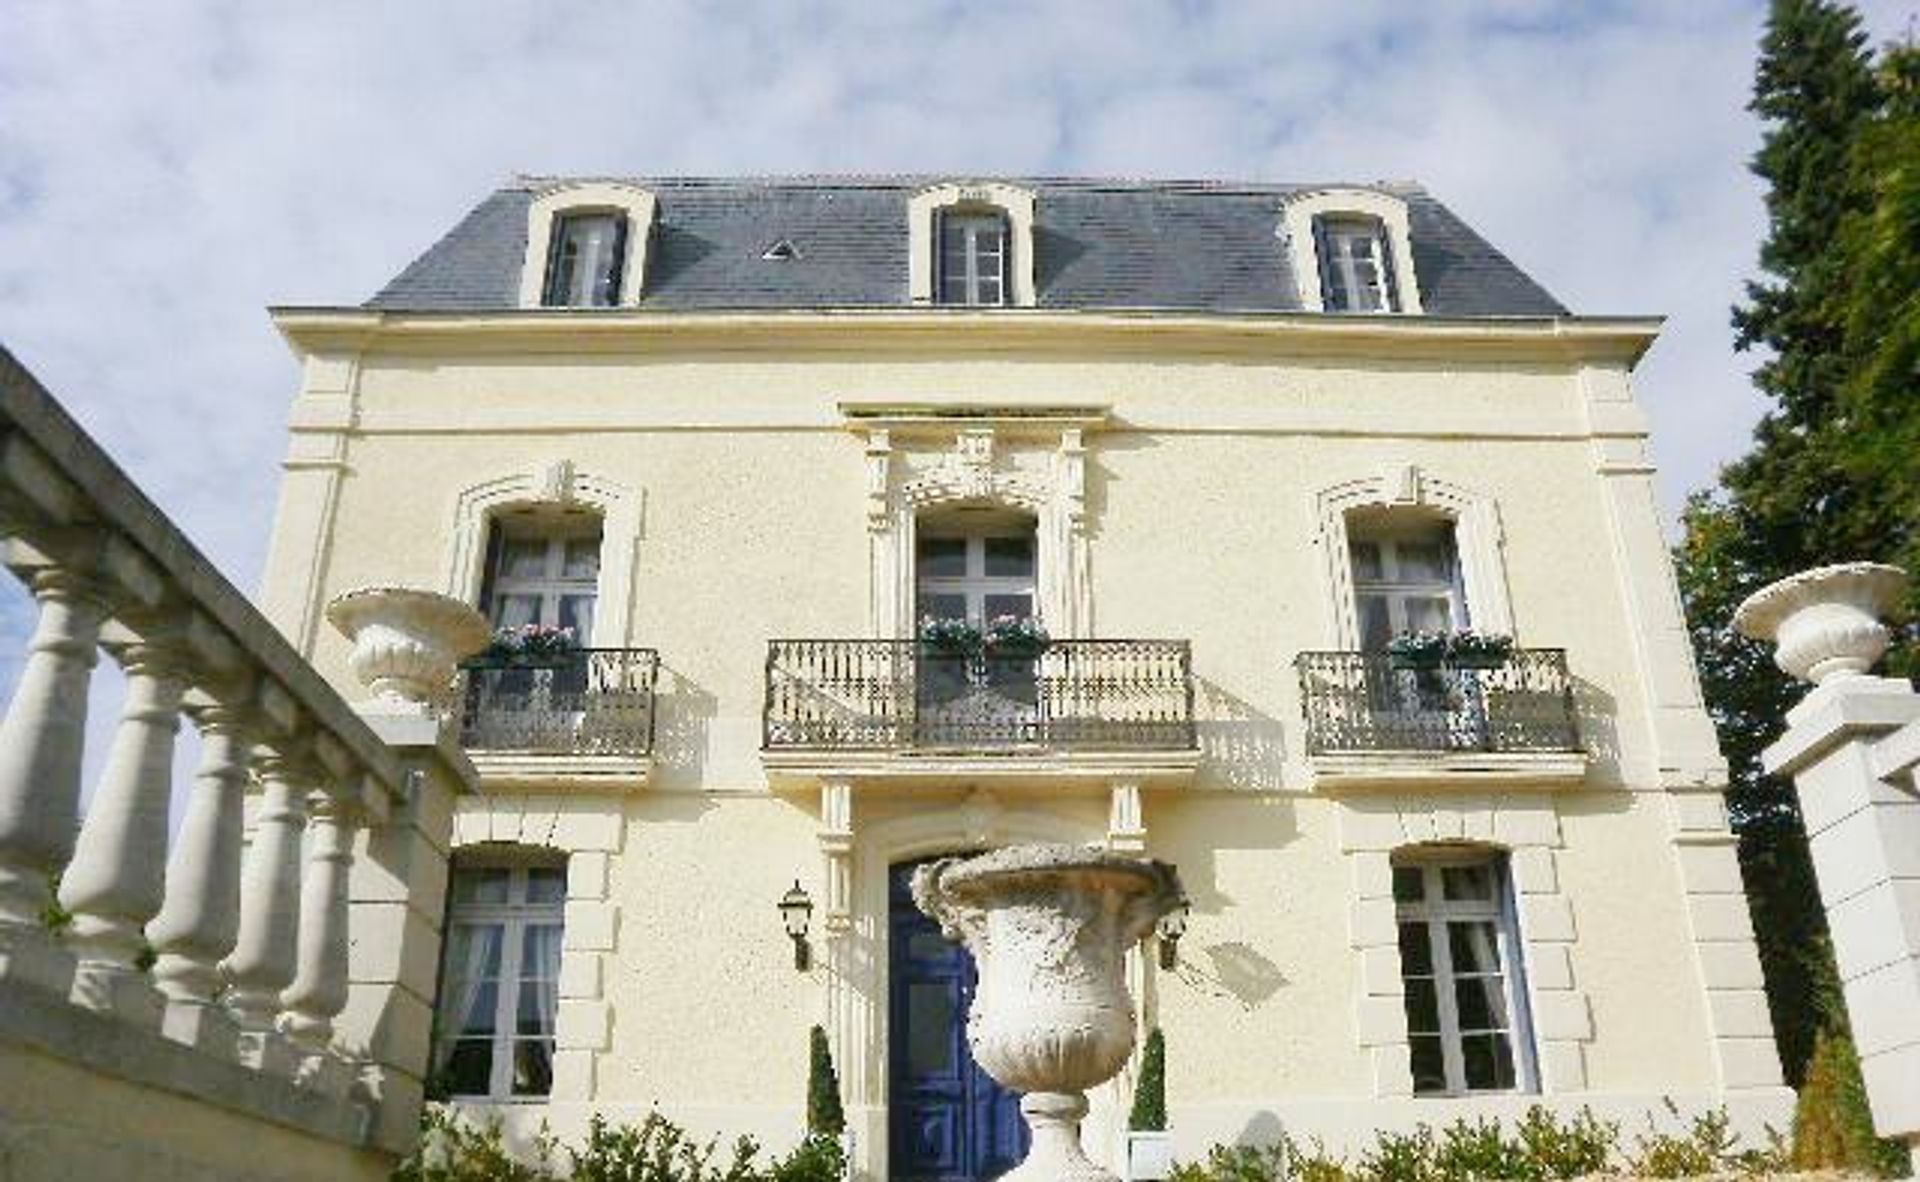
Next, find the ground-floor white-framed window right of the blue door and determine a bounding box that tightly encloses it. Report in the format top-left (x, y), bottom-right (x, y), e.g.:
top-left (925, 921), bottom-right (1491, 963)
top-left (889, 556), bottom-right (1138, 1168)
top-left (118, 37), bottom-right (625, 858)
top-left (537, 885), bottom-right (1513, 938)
top-left (1394, 850), bottom-right (1536, 1096)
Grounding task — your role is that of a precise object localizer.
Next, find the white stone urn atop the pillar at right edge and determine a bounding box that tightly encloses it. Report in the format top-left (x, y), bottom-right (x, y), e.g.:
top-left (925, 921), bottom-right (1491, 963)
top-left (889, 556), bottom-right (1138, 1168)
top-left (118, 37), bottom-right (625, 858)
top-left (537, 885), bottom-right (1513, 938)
top-left (1734, 562), bottom-right (1907, 685)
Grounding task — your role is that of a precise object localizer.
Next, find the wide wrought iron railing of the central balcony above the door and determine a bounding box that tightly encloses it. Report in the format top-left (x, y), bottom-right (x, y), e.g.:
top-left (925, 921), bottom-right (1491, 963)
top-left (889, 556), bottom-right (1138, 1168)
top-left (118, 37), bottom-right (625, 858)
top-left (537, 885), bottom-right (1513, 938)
top-left (764, 641), bottom-right (1194, 750)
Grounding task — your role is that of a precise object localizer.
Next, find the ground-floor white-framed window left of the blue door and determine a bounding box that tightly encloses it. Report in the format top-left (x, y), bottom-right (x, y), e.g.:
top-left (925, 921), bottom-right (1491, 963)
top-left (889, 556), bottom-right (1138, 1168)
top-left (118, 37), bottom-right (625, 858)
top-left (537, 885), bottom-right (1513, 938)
top-left (432, 860), bottom-right (566, 1099)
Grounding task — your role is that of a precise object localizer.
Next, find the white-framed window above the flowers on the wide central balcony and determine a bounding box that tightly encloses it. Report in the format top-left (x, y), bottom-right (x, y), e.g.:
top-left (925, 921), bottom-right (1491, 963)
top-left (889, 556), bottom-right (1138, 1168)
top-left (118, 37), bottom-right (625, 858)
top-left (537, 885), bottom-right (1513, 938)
top-left (914, 522), bottom-right (1039, 626)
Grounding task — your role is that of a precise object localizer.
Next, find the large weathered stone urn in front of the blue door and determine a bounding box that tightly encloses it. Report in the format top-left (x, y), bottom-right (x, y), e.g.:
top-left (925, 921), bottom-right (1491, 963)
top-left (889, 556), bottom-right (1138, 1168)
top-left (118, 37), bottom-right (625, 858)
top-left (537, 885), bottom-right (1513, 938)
top-left (914, 844), bottom-right (1181, 1182)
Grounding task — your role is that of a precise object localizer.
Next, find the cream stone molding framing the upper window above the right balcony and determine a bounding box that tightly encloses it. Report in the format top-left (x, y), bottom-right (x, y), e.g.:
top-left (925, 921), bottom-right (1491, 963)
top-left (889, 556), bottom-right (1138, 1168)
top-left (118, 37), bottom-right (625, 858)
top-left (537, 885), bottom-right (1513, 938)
top-left (1313, 462), bottom-right (1513, 650)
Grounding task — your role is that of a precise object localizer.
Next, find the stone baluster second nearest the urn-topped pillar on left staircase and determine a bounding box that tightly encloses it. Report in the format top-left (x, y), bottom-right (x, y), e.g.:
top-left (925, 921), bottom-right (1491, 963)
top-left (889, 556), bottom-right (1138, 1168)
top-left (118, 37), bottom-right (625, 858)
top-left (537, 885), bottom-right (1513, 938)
top-left (225, 752), bottom-right (307, 1075)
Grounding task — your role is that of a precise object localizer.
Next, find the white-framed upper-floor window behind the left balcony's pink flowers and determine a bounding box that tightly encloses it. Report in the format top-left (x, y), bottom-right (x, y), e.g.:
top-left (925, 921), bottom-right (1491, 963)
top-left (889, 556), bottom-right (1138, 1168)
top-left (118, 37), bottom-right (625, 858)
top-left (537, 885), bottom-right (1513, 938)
top-left (484, 512), bottom-right (601, 647)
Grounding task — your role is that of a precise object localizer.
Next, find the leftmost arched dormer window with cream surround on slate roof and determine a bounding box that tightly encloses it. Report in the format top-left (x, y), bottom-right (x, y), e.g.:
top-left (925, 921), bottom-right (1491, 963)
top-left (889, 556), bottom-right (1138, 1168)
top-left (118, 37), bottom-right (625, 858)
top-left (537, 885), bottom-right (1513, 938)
top-left (520, 182), bottom-right (655, 307)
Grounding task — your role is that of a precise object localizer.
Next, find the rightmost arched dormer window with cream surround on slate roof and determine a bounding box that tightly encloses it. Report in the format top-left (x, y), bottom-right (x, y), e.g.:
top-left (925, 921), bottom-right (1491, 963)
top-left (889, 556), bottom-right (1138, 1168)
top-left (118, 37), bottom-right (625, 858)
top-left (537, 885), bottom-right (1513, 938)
top-left (1283, 188), bottom-right (1421, 315)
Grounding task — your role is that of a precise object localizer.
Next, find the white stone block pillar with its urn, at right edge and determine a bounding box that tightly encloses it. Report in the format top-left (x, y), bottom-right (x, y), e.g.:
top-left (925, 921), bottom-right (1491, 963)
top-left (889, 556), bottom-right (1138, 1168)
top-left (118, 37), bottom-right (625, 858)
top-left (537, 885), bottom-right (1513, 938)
top-left (1734, 562), bottom-right (1920, 1157)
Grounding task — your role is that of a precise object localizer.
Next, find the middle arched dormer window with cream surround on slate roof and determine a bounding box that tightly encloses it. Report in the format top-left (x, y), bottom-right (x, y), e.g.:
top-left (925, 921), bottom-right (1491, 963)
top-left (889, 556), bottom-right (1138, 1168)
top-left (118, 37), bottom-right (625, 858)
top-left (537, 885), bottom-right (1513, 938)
top-left (906, 182), bottom-right (1033, 307)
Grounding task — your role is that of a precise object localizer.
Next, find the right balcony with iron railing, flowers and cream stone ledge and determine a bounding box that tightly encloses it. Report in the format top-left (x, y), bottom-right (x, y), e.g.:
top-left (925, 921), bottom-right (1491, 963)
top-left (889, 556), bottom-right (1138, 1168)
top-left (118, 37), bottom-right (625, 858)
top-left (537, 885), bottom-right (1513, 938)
top-left (1294, 649), bottom-right (1586, 783)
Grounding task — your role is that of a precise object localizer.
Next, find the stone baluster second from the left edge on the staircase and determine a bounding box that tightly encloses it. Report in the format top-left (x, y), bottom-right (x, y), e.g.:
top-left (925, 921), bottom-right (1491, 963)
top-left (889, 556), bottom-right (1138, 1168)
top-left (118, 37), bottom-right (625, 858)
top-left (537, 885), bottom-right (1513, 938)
top-left (60, 641), bottom-right (186, 1027)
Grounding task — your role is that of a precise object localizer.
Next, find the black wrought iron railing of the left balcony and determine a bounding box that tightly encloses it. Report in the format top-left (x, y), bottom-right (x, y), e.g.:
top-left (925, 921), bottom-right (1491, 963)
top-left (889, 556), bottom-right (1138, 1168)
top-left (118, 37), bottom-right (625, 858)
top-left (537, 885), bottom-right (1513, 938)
top-left (461, 649), bottom-right (660, 756)
